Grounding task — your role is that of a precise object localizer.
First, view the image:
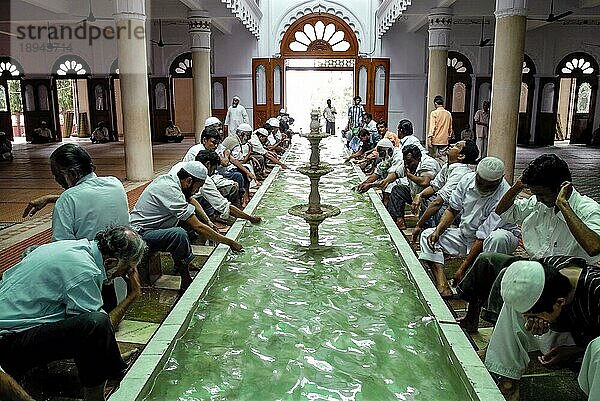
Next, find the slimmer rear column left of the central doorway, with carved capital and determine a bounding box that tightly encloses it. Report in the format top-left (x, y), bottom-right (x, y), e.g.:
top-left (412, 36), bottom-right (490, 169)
top-left (188, 10), bottom-right (212, 143)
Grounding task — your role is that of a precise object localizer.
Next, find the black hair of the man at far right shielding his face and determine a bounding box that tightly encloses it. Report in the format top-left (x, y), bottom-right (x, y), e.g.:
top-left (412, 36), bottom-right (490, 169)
top-left (521, 153), bottom-right (571, 192)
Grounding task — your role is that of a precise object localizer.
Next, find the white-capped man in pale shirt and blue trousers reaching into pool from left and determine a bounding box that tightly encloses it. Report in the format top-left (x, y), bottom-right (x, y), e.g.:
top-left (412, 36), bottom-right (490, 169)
top-left (130, 161), bottom-right (242, 291)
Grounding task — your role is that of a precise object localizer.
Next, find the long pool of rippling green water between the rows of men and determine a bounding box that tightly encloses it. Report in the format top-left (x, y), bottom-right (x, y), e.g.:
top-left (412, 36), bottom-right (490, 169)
top-left (145, 138), bottom-right (471, 401)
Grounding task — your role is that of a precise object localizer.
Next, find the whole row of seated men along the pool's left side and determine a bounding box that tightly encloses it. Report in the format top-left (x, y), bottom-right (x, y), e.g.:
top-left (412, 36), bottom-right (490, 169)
top-left (0, 111), bottom-right (289, 401)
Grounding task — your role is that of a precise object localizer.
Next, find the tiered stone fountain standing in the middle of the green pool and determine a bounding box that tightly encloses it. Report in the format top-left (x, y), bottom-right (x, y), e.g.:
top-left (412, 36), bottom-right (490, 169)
top-left (289, 109), bottom-right (340, 247)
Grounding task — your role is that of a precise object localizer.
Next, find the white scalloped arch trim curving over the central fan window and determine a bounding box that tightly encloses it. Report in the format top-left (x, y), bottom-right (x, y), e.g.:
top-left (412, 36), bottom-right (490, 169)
top-left (273, 1), bottom-right (366, 55)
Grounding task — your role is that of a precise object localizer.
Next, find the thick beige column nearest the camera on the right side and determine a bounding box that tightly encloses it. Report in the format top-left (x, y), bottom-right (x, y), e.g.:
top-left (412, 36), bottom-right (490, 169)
top-left (488, 0), bottom-right (527, 182)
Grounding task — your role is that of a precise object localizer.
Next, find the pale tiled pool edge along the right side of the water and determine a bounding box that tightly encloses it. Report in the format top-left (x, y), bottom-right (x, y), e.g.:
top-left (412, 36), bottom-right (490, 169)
top-left (353, 159), bottom-right (504, 401)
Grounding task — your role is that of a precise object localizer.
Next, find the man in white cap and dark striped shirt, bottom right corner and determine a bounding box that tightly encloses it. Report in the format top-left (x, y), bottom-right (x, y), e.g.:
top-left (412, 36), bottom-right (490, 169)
top-left (485, 256), bottom-right (600, 401)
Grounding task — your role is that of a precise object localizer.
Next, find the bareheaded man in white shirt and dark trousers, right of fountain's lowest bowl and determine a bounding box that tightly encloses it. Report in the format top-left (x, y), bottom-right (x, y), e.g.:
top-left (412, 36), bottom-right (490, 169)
top-left (387, 145), bottom-right (440, 230)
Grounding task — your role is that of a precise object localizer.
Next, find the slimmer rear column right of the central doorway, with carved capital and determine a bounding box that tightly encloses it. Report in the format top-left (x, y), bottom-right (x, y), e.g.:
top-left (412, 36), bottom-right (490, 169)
top-left (425, 7), bottom-right (452, 136)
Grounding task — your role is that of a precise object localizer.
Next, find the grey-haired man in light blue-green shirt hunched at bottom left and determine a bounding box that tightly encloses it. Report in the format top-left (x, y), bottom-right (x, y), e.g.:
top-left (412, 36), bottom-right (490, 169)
top-left (0, 226), bottom-right (146, 401)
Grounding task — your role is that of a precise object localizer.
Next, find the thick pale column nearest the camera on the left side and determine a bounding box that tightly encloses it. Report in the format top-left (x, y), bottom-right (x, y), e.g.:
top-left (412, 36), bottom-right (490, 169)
top-left (114, 0), bottom-right (154, 181)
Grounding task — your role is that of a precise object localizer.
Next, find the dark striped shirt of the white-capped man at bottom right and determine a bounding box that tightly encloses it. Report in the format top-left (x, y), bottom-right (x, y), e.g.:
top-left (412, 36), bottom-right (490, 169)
top-left (540, 256), bottom-right (600, 347)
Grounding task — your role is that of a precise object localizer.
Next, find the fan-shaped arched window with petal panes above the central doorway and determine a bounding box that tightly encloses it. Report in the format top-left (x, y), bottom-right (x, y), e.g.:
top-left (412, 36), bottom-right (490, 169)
top-left (281, 13), bottom-right (358, 57)
